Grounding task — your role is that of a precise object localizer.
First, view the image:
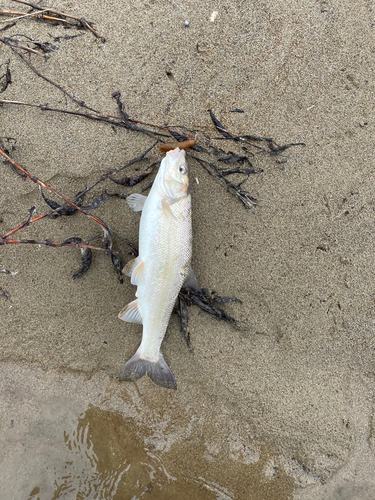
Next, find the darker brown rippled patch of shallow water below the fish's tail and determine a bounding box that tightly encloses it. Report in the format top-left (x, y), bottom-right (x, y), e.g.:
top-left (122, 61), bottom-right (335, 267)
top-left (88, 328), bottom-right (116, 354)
top-left (25, 406), bottom-right (214, 500)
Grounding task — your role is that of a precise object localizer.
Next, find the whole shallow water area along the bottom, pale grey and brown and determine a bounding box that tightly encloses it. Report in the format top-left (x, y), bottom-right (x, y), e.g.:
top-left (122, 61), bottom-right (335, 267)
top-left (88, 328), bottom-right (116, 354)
top-left (0, 366), bottom-right (290, 500)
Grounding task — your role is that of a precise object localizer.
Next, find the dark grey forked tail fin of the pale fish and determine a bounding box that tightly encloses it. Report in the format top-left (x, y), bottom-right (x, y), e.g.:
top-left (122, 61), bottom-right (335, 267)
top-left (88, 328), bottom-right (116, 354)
top-left (119, 351), bottom-right (177, 390)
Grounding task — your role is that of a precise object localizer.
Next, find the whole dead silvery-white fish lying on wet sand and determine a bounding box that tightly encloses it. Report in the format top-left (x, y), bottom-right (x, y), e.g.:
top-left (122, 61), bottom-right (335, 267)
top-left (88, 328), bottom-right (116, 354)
top-left (118, 147), bottom-right (201, 389)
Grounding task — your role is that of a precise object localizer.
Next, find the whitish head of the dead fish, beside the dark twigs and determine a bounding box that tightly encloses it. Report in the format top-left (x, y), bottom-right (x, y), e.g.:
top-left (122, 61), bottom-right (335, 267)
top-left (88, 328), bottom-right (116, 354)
top-left (158, 148), bottom-right (189, 202)
